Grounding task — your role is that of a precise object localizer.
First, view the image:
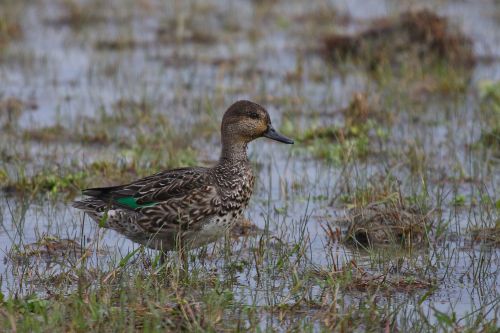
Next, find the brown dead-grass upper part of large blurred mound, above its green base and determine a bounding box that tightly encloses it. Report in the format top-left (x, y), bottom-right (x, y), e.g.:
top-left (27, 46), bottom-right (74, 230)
top-left (323, 9), bottom-right (474, 69)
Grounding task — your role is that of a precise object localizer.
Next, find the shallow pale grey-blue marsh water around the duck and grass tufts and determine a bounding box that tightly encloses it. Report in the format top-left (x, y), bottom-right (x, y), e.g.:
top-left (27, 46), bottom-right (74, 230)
top-left (0, 1), bottom-right (500, 325)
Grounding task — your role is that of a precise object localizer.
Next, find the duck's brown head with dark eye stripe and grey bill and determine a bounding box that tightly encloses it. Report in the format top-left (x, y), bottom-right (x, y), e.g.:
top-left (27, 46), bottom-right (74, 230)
top-left (221, 101), bottom-right (293, 144)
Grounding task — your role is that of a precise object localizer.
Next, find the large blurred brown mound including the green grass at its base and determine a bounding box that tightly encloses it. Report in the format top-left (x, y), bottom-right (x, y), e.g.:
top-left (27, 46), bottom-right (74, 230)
top-left (321, 9), bottom-right (476, 101)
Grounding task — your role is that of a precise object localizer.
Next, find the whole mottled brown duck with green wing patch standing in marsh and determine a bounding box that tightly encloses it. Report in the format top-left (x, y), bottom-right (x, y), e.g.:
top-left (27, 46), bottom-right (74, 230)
top-left (73, 101), bottom-right (293, 251)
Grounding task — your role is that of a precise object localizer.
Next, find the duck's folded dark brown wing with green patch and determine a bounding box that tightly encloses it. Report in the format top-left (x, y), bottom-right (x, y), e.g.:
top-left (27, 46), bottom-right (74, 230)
top-left (78, 168), bottom-right (212, 210)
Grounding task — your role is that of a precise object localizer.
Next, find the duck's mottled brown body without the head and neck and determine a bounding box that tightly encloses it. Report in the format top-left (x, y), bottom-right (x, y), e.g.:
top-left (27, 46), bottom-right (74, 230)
top-left (74, 163), bottom-right (253, 250)
